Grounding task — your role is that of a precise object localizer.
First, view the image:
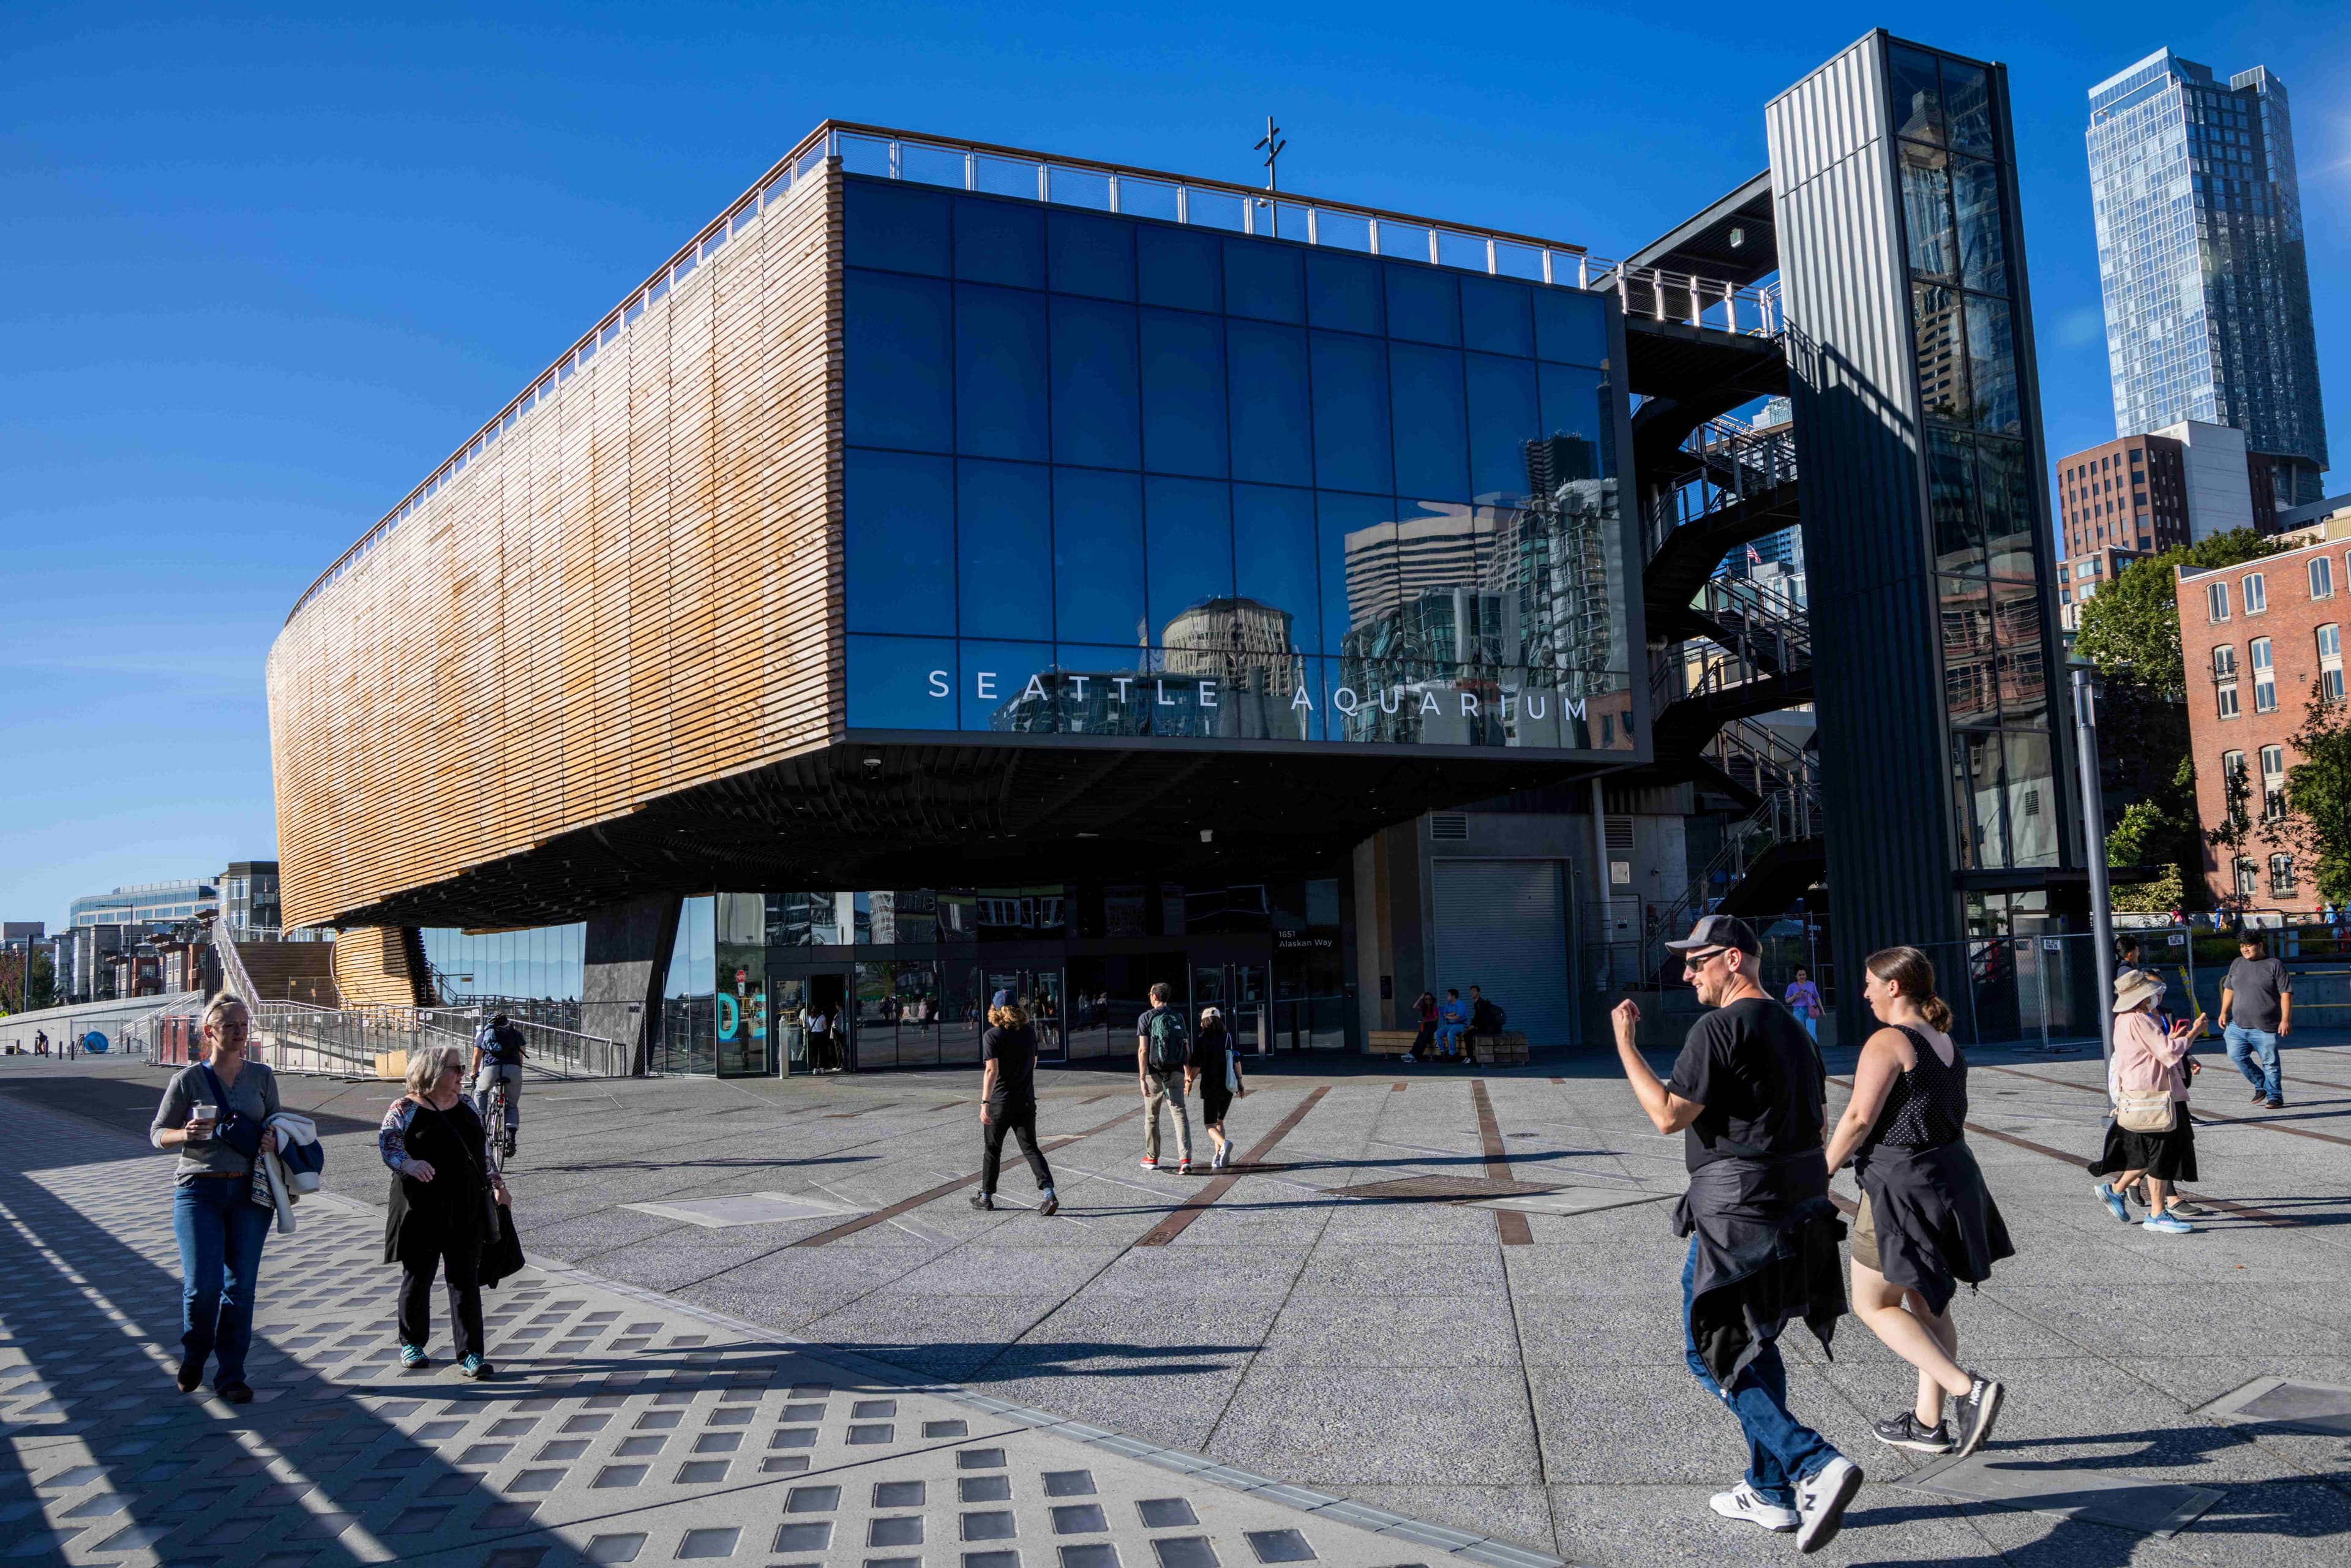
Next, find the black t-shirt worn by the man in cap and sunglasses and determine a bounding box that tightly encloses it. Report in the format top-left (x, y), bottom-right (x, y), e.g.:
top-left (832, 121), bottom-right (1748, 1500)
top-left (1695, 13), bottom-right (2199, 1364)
top-left (1665, 997), bottom-right (1829, 1171)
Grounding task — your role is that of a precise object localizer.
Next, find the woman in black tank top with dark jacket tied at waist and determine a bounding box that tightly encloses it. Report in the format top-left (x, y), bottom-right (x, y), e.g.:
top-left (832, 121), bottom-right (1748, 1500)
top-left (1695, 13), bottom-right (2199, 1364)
top-left (1827, 947), bottom-right (2017, 1455)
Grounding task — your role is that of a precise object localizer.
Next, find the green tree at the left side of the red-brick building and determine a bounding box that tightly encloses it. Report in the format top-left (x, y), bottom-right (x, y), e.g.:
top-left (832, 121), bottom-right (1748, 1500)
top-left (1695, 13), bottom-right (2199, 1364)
top-left (2074, 529), bottom-right (2276, 910)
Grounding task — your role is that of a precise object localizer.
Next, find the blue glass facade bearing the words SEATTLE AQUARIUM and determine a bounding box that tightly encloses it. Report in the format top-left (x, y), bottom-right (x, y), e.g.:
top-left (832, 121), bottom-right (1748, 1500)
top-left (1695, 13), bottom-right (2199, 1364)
top-left (844, 179), bottom-right (1636, 748)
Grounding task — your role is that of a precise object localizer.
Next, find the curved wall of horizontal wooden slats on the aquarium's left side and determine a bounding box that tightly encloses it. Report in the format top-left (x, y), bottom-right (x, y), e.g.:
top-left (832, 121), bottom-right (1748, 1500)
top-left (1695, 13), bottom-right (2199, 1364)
top-left (268, 169), bottom-right (846, 924)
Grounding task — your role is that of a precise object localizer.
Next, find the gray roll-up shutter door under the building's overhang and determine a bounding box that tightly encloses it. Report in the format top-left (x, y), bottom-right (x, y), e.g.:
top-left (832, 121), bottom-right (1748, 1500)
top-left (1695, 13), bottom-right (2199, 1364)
top-left (1434, 860), bottom-right (1575, 1046)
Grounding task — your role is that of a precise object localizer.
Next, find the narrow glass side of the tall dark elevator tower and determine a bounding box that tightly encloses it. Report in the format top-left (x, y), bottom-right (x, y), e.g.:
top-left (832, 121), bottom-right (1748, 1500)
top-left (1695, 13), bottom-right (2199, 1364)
top-left (1888, 45), bottom-right (2064, 870)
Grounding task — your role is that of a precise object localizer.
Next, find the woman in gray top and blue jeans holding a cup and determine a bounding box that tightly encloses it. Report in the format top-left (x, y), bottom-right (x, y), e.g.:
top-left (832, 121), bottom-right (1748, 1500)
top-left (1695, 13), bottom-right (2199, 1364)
top-left (148, 992), bottom-right (277, 1403)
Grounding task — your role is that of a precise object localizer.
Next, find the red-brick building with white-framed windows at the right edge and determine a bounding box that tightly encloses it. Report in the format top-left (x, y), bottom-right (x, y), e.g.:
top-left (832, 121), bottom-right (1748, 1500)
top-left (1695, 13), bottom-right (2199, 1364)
top-left (2180, 517), bottom-right (2351, 912)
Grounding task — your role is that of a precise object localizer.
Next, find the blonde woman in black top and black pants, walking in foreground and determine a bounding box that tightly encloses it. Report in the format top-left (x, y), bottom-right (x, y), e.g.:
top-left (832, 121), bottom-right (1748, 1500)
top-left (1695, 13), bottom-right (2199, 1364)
top-left (376, 1046), bottom-right (520, 1378)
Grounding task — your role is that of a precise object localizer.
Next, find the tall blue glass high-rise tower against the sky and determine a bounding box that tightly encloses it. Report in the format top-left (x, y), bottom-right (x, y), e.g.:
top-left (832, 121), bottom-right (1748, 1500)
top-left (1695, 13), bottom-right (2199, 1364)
top-left (2090, 50), bottom-right (2328, 506)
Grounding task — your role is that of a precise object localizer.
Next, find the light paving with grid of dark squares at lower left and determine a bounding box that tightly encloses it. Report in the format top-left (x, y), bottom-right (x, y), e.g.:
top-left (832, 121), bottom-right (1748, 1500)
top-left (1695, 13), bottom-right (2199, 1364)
top-left (0, 1112), bottom-right (1556, 1568)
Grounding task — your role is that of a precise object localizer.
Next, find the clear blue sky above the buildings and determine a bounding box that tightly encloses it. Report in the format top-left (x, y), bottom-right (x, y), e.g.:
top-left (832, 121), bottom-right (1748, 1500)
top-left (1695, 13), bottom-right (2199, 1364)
top-left (0, 0), bottom-right (2351, 921)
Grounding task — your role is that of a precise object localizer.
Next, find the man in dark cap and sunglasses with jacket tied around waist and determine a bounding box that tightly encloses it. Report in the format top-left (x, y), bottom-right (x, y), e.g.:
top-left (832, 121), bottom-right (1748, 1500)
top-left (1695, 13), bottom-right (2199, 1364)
top-left (1615, 915), bottom-right (1862, 1551)
